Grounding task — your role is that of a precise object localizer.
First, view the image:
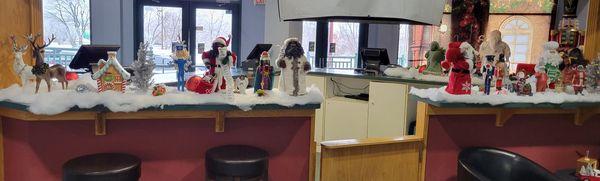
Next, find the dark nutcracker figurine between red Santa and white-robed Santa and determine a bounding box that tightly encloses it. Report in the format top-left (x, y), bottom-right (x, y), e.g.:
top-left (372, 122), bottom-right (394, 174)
top-left (254, 51), bottom-right (275, 96)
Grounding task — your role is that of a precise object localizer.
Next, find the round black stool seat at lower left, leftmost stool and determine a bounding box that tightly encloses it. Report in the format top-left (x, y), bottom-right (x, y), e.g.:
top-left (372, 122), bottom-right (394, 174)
top-left (63, 153), bottom-right (141, 181)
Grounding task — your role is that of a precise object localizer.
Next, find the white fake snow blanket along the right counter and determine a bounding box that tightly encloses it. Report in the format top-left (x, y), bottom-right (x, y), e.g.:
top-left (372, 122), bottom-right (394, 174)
top-left (410, 86), bottom-right (600, 105)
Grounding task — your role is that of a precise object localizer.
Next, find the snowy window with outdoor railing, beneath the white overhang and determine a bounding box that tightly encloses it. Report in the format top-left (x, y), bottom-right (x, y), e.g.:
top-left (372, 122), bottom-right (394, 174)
top-left (327, 22), bottom-right (360, 69)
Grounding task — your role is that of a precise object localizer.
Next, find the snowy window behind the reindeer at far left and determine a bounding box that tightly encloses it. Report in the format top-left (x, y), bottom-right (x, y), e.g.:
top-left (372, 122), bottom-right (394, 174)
top-left (42, 0), bottom-right (90, 67)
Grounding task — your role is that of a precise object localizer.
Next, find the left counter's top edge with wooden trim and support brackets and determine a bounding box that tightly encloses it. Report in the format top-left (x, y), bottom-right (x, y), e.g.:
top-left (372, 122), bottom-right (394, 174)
top-left (0, 101), bottom-right (320, 135)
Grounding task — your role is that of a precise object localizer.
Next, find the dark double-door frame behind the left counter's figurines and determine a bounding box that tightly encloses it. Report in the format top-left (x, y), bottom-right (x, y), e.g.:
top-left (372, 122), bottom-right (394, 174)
top-left (133, 0), bottom-right (241, 65)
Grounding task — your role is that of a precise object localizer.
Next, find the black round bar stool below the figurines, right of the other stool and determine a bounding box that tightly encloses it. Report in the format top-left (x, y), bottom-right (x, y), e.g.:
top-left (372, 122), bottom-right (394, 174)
top-left (205, 145), bottom-right (269, 181)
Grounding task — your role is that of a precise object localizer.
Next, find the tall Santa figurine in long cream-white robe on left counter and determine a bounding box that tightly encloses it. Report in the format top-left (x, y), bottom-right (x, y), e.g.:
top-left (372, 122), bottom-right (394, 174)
top-left (277, 38), bottom-right (310, 96)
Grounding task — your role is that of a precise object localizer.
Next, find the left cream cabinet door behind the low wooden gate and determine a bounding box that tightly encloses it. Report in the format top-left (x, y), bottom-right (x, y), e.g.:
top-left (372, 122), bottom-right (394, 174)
top-left (323, 97), bottom-right (369, 141)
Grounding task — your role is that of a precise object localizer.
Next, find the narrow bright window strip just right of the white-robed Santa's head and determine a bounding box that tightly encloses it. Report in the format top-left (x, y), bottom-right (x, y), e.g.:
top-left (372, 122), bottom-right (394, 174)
top-left (302, 21), bottom-right (317, 67)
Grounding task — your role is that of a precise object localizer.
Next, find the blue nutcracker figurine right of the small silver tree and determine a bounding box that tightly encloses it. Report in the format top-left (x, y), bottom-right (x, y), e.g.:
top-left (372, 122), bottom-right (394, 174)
top-left (171, 42), bottom-right (192, 92)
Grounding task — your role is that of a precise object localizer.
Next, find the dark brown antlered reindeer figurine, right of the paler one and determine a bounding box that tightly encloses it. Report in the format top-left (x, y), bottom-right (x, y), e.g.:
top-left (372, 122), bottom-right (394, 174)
top-left (27, 34), bottom-right (69, 94)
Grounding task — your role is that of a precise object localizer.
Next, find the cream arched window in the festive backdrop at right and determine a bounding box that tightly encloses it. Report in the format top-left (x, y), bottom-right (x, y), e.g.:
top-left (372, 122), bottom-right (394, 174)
top-left (500, 16), bottom-right (532, 72)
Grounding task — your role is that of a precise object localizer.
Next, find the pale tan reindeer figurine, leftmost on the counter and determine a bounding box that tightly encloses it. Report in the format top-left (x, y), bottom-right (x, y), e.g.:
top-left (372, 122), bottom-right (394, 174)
top-left (10, 35), bottom-right (34, 87)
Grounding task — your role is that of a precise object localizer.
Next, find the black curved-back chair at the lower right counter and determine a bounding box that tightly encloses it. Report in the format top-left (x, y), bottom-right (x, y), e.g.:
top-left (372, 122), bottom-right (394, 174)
top-left (457, 147), bottom-right (560, 181)
